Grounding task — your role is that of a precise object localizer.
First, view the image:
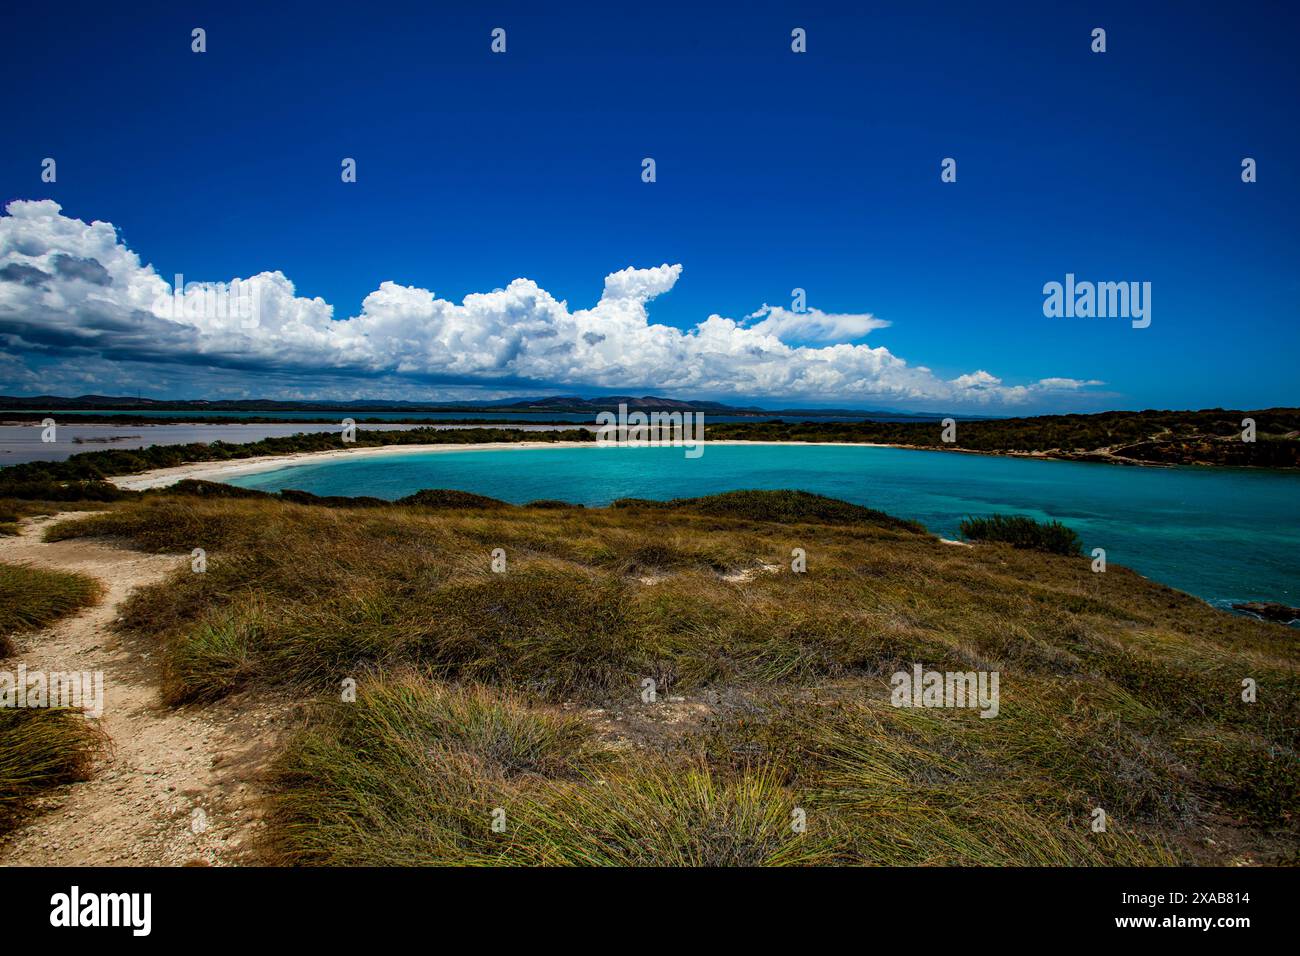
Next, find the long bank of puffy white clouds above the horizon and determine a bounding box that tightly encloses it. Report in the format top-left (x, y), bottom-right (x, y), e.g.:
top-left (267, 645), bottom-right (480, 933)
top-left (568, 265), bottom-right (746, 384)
top-left (0, 200), bottom-right (1102, 406)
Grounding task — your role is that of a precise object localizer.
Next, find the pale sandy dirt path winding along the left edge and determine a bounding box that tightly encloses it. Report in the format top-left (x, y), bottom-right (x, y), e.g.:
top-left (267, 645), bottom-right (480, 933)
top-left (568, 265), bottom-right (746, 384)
top-left (0, 512), bottom-right (287, 866)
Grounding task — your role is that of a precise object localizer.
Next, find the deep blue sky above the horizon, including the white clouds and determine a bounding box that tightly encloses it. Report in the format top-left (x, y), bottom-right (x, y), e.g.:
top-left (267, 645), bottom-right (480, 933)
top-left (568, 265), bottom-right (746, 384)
top-left (0, 3), bottom-right (1300, 414)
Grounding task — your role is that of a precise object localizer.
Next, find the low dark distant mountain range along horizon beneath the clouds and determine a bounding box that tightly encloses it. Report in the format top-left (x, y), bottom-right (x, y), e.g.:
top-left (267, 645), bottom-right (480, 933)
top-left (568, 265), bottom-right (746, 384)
top-left (0, 395), bottom-right (961, 420)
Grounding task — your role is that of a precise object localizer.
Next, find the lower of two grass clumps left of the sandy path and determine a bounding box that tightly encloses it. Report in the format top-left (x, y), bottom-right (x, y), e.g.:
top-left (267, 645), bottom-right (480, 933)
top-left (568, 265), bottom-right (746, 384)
top-left (0, 708), bottom-right (104, 834)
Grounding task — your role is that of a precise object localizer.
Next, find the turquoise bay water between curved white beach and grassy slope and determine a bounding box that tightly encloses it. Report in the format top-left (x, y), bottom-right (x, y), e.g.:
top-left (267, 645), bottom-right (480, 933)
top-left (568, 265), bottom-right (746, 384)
top-left (230, 444), bottom-right (1300, 605)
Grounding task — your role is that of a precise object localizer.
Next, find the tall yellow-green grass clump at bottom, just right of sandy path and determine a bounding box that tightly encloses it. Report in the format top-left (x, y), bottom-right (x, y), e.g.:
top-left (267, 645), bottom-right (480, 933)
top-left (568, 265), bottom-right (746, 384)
top-left (272, 674), bottom-right (602, 865)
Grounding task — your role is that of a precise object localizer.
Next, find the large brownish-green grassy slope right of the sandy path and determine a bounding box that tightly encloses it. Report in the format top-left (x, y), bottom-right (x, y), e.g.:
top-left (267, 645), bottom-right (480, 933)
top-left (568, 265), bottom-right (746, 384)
top-left (35, 483), bottom-right (1300, 865)
